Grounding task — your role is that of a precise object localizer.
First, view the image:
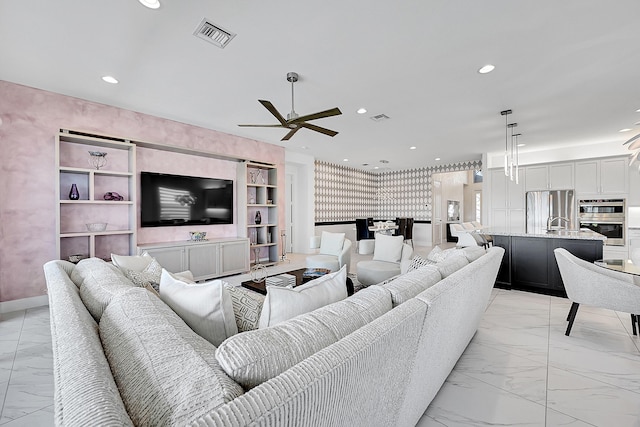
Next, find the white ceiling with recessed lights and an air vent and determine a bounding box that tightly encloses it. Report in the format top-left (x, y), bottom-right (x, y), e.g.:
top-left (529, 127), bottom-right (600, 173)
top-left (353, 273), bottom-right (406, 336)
top-left (0, 0), bottom-right (640, 170)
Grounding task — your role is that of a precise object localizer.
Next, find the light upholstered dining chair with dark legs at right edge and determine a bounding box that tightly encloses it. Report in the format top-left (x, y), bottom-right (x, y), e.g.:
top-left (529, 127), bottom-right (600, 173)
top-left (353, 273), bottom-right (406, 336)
top-left (553, 248), bottom-right (640, 336)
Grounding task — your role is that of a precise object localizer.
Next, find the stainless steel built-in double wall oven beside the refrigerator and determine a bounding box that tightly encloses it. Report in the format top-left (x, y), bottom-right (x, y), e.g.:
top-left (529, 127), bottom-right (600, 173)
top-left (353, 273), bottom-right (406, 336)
top-left (578, 199), bottom-right (625, 246)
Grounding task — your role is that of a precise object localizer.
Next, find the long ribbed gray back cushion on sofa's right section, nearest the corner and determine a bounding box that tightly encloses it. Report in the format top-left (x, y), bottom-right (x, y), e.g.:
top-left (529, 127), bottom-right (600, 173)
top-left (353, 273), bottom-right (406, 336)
top-left (216, 286), bottom-right (392, 389)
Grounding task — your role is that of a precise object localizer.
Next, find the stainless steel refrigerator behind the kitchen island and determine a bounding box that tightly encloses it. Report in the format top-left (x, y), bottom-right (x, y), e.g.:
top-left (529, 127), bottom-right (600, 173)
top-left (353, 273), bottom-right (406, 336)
top-left (526, 190), bottom-right (578, 233)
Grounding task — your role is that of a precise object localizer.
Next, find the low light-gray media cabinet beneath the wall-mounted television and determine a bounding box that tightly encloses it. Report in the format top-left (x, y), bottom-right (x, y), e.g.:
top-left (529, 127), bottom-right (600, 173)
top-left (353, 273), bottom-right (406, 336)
top-left (138, 237), bottom-right (249, 280)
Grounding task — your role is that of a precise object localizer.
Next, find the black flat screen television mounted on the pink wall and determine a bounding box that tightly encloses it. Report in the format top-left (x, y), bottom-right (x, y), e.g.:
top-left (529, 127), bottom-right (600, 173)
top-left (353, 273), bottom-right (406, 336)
top-left (140, 172), bottom-right (233, 227)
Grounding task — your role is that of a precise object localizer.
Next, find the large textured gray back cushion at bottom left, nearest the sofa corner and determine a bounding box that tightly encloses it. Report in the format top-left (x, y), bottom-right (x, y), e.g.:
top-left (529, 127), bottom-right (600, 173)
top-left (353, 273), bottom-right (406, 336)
top-left (100, 288), bottom-right (243, 425)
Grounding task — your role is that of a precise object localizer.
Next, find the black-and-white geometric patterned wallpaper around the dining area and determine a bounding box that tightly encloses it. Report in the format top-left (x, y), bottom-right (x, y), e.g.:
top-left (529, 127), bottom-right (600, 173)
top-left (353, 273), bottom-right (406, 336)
top-left (315, 160), bottom-right (482, 222)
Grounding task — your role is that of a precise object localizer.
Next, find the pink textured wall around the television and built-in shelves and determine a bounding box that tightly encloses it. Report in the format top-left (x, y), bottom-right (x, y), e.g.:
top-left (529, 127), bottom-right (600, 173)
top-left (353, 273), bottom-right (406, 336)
top-left (0, 80), bottom-right (285, 302)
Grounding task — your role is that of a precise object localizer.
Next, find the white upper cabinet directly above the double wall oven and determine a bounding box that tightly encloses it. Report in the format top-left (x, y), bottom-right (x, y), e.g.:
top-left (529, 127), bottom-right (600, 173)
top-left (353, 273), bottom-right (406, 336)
top-left (575, 157), bottom-right (629, 195)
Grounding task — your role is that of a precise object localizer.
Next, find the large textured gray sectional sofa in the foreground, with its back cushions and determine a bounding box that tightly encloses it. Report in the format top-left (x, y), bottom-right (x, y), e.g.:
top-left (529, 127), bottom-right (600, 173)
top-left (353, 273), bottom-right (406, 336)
top-left (44, 247), bottom-right (504, 426)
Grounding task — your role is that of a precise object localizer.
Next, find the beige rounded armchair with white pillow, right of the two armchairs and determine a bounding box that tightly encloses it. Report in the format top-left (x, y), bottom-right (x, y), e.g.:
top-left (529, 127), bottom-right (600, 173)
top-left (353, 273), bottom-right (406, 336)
top-left (356, 233), bottom-right (413, 286)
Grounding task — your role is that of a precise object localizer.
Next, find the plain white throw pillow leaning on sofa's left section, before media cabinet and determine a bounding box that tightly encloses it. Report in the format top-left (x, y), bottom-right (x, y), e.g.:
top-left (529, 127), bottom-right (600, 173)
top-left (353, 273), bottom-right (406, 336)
top-left (160, 269), bottom-right (238, 346)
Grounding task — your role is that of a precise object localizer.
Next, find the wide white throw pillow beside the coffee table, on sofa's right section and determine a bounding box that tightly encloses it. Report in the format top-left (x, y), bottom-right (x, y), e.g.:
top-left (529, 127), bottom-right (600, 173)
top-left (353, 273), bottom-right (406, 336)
top-left (258, 265), bottom-right (347, 329)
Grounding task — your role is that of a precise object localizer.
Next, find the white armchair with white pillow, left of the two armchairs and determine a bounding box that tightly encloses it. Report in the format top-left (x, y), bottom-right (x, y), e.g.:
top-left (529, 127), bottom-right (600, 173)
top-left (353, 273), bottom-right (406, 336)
top-left (306, 231), bottom-right (351, 274)
